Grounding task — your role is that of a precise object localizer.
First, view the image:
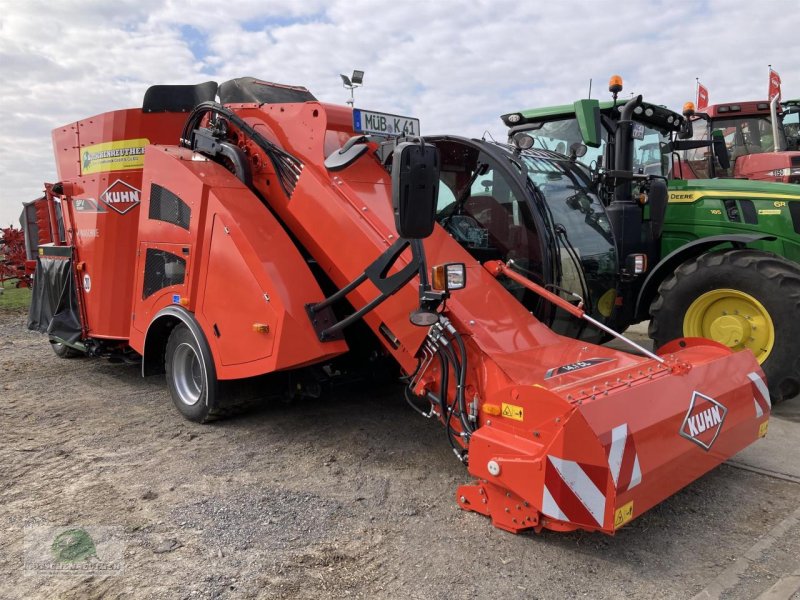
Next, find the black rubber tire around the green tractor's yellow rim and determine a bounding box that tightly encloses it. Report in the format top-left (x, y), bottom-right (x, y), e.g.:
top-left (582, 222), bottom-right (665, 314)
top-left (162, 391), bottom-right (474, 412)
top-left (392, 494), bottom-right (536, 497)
top-left (648, 249), bottom-right (800, 402)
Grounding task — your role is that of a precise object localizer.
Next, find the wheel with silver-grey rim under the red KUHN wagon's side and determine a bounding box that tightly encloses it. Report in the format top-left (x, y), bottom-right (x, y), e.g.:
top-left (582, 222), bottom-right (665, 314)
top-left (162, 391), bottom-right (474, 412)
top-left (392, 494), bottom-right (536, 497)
top-left (164, 324), bottom-right (218, 423)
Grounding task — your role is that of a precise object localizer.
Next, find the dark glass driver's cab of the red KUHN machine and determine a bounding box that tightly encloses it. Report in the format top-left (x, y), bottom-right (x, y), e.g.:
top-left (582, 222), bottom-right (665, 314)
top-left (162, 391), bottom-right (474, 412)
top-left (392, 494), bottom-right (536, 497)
top-left (426, 136), bottom-right (621, 339)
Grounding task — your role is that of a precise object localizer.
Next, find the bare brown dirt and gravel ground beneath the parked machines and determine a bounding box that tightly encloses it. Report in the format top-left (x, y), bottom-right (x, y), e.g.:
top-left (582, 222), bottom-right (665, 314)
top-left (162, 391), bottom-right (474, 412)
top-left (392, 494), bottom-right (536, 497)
top-left (0, 312), bottom-right (800, 599)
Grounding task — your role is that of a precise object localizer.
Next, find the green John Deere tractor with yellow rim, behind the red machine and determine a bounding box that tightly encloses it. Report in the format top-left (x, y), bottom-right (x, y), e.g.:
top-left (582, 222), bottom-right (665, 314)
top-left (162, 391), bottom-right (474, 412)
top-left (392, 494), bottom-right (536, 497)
top-left (502, 90), bottom-right (800, 400)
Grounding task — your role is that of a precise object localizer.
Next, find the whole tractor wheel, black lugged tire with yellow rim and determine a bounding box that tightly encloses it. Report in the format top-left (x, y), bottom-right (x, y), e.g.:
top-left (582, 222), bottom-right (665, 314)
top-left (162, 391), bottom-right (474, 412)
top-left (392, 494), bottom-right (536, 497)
top-left (648, 249), bottom-right (800, 402)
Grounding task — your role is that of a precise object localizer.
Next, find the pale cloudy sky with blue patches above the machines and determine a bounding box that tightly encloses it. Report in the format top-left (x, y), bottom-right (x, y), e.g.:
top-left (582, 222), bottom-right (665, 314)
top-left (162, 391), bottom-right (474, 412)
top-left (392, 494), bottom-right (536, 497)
top-left (0, 0), bottom-right (800, 225)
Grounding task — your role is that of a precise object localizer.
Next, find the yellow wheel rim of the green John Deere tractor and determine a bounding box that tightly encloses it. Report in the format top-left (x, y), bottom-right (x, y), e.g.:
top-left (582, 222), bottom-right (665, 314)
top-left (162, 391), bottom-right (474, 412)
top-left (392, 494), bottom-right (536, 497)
top-left (683, 289), bottom-right (775, 364)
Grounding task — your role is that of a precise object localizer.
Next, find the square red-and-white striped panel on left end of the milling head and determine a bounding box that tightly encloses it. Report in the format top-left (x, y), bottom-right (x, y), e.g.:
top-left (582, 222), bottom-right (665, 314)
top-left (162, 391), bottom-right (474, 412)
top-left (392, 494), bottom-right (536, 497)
top-left (542, 454), bottom-right (608, 527)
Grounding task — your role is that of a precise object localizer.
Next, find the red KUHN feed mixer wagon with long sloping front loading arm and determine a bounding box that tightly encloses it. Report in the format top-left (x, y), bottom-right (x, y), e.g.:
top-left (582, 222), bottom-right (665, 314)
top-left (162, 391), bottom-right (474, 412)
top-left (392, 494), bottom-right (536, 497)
top-left (29, 78), bottom-right (770, 533)
